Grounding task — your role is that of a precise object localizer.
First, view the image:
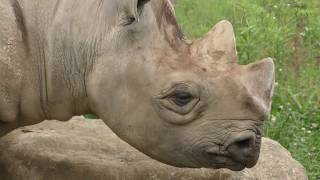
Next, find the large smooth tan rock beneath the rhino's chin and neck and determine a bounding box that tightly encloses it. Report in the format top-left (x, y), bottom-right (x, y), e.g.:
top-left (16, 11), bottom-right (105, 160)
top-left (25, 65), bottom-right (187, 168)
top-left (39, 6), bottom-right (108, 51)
top-left (0, 117), bottom-right (307, 180)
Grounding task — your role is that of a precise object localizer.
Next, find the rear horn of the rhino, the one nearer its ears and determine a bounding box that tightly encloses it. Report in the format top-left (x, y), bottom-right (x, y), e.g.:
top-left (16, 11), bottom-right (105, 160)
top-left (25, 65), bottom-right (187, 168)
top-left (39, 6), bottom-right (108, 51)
top-left (193, 20), bottom-right (238, 63)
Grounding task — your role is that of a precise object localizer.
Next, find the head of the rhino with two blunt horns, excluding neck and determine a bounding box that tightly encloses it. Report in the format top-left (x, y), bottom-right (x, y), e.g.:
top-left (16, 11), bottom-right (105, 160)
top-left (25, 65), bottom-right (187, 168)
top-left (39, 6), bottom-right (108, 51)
top-left (87, 0), bottom-right (274, 170)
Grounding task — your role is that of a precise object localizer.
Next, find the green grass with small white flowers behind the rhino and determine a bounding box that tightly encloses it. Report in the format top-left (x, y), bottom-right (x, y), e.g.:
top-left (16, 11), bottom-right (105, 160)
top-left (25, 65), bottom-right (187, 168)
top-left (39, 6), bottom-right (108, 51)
top-left (176, 0), bottom-right (320, 180)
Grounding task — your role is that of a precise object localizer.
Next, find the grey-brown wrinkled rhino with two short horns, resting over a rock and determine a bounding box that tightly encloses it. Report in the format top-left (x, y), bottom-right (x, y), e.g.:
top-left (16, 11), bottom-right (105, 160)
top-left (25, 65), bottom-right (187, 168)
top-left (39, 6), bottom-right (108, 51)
top-left (0, 0), bottom-right (274, 170)
